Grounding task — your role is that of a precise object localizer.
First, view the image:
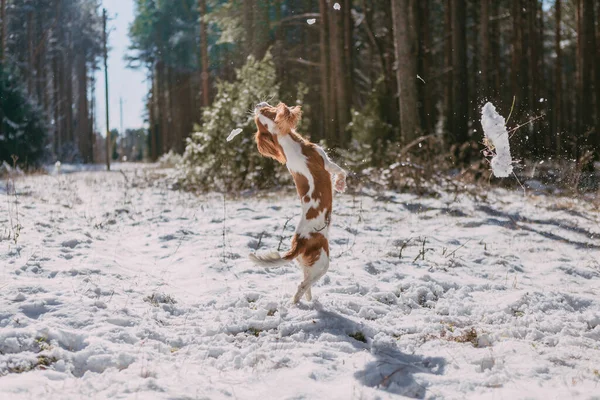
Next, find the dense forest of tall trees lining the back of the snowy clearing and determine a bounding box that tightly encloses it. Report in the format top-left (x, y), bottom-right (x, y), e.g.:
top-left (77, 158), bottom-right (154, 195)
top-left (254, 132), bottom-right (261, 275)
top-left (0, 0), bottom-right (600, 186)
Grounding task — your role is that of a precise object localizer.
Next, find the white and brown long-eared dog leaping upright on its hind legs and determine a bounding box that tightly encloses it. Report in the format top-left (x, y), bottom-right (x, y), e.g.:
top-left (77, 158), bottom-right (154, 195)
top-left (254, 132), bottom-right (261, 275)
top-left (250, 103), bottom-right (346, 303)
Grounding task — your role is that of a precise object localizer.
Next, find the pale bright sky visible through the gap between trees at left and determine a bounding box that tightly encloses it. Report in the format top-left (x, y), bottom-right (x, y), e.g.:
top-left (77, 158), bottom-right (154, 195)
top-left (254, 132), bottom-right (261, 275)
top-left (96, 0), bottom-right (148, 134)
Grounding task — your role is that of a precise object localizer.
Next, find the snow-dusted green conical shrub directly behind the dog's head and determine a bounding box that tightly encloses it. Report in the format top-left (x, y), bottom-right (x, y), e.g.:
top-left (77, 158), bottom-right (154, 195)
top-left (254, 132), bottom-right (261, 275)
top-left (179, 53), bottom-right (306, 191)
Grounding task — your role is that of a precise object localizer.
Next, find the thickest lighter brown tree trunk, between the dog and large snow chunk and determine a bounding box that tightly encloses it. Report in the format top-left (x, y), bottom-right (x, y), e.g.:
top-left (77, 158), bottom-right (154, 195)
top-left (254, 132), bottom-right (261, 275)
top-left (392, 0), bottom-right (421, 143)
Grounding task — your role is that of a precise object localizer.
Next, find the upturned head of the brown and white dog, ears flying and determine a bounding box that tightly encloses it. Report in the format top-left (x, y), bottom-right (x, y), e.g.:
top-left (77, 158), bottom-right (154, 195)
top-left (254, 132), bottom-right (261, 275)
top-left (254, 102), bottom-right (302, 135)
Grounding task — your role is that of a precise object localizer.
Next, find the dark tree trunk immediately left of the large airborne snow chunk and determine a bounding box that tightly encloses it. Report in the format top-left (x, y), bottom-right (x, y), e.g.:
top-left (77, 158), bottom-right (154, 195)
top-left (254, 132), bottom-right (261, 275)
top-left (452, 0), bottom-right (469, 144)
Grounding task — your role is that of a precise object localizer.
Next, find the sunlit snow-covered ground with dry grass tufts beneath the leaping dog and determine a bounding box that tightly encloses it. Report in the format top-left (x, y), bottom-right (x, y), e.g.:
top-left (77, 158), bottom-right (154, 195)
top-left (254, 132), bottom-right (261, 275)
top-left (0, 165), bottom-right (600, 399)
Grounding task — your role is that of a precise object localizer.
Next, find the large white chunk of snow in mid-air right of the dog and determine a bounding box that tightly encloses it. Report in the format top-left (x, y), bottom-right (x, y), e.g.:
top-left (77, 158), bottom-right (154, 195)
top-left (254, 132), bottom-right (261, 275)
top-left (481, 102), bottom-right (513, 178)
